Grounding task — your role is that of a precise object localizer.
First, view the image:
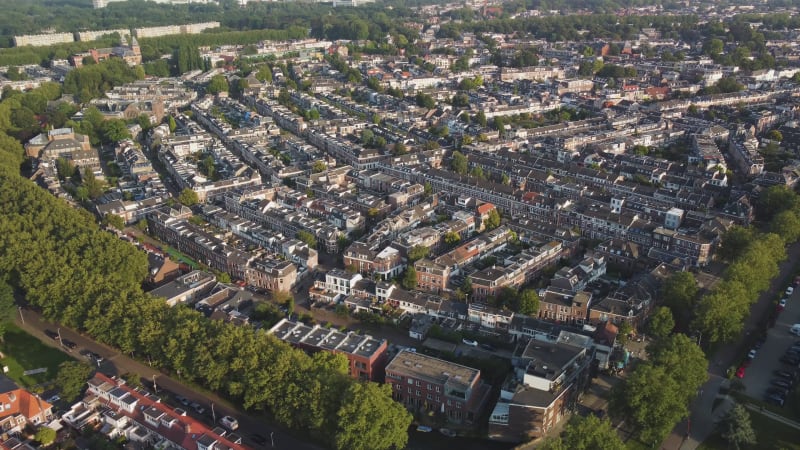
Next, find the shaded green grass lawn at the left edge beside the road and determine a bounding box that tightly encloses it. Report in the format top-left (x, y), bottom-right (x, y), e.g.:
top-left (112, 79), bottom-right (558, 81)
top-left (0, 324), bottom-right (72, 388)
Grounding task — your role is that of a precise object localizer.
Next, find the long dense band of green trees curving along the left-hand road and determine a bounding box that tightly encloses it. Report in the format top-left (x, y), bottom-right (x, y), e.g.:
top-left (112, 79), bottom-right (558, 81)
top-left (0, 166), bottom-right (411, 449)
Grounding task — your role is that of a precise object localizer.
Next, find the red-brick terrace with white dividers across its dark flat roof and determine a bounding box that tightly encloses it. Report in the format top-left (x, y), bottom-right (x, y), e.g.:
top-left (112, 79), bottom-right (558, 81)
top-left (269, 319), bottom-right (388, 383)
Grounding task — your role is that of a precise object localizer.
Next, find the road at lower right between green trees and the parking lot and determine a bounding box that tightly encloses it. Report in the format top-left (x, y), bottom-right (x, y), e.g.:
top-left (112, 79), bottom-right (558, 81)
top-left (661, 242), bottom-right (800, 450)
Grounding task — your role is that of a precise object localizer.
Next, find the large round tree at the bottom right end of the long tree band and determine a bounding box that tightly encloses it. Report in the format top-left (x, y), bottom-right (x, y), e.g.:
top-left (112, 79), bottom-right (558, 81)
top-left (335, 382), bottom-right (413, 450)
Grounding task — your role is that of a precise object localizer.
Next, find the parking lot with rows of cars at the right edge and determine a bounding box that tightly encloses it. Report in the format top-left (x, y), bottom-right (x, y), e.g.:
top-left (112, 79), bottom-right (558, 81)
top-left (742, 284), bottom-right (800, 400)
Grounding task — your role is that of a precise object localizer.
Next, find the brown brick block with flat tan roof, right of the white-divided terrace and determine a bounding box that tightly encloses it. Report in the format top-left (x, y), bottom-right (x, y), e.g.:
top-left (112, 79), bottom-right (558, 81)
top-left (386, 350), bottom-right (490, 424)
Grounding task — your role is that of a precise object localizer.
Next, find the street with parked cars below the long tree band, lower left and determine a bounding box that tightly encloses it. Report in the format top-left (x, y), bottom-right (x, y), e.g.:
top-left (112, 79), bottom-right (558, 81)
top-left (16, 309), bottom-right (323, 450)
